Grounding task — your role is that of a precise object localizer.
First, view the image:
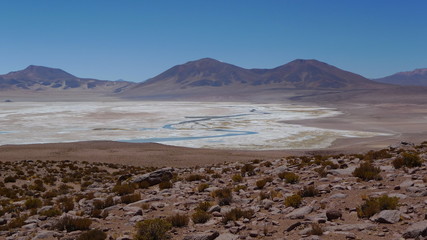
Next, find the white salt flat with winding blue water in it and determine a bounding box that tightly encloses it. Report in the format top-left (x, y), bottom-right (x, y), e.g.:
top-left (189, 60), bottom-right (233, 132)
top-left (0, 102), bottom-right (384, 150)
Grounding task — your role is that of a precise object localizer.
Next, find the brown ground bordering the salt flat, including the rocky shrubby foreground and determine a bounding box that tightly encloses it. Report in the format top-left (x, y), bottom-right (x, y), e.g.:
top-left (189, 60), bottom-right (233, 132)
top-left (0, 100), bottom-right (427, 240)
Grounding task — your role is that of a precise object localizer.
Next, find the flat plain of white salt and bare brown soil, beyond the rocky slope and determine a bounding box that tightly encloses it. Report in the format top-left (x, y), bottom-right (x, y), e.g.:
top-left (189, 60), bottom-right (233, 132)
top-left (0, 101), bottom-right (427, 166)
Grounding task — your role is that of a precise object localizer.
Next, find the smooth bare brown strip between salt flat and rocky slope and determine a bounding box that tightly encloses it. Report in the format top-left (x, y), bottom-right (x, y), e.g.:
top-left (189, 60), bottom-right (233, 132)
top-left (0, 141), bottom-right (298, 167)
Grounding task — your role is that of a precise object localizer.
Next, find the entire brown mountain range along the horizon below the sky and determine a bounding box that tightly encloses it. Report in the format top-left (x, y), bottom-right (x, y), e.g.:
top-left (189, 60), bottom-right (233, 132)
top-left (0, 58), bottom-right (427, 101)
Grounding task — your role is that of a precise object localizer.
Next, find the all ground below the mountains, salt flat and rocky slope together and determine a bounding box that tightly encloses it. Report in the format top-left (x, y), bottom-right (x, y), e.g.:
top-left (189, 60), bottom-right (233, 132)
top-left (0, 97), bottom-right (427, 240)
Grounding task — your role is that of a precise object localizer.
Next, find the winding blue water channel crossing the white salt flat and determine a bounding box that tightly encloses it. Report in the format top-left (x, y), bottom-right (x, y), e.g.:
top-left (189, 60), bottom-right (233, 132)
top-left (122, 111), bottom-right (260, 143)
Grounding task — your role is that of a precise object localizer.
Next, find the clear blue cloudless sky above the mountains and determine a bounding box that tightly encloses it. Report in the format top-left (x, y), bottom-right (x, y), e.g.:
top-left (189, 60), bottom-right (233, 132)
top-left (0, 0), bottom-right (427, 81)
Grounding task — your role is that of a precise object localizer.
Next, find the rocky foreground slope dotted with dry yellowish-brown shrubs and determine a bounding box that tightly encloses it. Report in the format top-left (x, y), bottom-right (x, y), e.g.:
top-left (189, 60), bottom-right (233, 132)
top-left (0, 142), bottom-right (427, 240)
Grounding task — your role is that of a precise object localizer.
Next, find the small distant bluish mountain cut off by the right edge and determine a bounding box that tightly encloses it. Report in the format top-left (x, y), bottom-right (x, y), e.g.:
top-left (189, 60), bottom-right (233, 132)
top-left (374, 68), bottom-right (427, 87)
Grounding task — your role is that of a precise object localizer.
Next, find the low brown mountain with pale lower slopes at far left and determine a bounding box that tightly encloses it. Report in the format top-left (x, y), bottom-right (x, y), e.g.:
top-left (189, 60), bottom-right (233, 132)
top-left (0, 65), bottom-right (133, 93)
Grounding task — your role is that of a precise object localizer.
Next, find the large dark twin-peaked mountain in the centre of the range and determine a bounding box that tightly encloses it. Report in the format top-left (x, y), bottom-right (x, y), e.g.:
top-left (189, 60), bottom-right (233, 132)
top-left (122, 58), bottom-right (387, 99)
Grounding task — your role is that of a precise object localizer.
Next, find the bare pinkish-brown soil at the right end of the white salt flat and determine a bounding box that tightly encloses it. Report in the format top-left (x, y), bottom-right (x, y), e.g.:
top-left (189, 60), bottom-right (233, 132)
top-left (289, 103), bottom-right (427, 152)
